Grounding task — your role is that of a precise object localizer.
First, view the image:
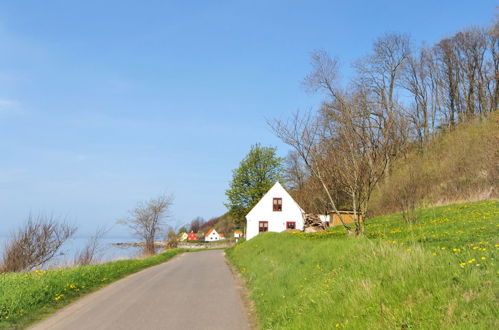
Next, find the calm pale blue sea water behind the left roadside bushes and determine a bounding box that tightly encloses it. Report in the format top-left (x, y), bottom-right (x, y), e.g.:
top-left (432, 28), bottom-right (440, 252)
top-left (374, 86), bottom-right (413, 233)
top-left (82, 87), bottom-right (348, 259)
top-left (0, 236), bottom-right (146, 267)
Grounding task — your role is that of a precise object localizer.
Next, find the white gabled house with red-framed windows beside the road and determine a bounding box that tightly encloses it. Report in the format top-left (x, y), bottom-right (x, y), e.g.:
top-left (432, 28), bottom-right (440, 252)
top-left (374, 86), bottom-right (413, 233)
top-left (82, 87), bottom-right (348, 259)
top-left (246, 182), bottom-right (305, 239)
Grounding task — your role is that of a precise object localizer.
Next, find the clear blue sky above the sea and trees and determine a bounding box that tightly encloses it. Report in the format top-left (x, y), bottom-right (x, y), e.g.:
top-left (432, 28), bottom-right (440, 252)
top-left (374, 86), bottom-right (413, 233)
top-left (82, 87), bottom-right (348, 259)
top-left (0, 0), bottom-right (497, 235)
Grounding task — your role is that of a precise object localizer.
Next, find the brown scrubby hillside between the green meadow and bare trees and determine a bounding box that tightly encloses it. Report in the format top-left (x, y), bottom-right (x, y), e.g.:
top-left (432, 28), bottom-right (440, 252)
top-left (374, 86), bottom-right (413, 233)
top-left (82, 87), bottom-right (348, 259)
top-left (370, 111), bottom-right (499, 215)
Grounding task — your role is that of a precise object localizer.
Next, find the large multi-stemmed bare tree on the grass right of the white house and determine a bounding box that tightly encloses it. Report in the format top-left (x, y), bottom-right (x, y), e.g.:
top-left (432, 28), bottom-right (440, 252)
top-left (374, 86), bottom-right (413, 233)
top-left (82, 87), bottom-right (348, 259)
top-left (269, 48), bottom-right (408, 235)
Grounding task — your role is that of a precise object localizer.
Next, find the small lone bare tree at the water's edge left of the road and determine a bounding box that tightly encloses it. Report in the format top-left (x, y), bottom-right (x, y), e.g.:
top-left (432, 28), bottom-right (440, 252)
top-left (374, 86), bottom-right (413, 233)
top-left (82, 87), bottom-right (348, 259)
top-left (118, 195), bottom-right (173, 254)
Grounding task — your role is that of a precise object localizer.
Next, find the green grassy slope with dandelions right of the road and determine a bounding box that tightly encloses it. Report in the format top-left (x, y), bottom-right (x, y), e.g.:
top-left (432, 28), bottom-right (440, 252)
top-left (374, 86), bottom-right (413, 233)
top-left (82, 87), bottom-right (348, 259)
top-left (227, 201), bottom-right (499, 329)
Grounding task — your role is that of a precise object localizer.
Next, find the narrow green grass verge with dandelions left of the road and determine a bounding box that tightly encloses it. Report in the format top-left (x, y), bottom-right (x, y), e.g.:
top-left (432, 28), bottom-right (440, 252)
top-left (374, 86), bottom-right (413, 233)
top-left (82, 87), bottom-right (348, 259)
top-left (0, 249), bottom-right (186, 328)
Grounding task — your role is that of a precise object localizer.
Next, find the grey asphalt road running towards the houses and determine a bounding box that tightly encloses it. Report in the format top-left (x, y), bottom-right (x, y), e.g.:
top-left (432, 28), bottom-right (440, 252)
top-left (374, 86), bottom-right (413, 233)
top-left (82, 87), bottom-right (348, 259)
top-left (32, 250), bottom-right (250, 330)
